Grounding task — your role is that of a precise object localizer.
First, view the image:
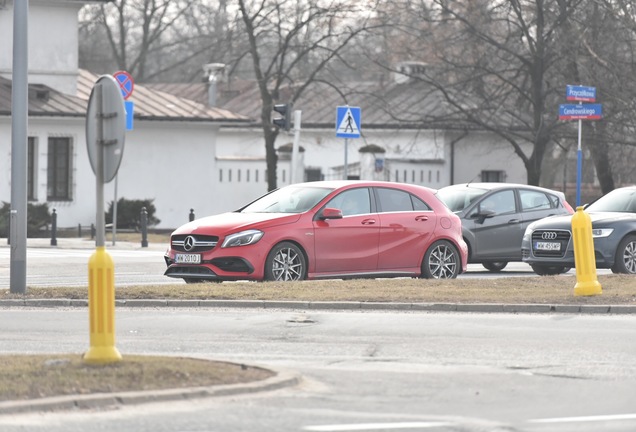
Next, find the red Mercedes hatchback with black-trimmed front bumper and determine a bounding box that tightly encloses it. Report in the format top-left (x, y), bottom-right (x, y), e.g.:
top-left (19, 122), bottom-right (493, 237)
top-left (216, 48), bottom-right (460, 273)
top-left (165, 181), bottom-right (467, 283)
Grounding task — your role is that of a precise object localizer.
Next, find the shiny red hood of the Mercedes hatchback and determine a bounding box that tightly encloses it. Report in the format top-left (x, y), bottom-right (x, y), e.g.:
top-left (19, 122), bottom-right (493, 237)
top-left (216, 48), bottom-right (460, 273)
top-left (172, 212), bottom-right (301, 235)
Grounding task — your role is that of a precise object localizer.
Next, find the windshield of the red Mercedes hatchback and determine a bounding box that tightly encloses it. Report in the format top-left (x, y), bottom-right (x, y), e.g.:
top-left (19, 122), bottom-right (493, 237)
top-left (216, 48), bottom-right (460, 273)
top-left (239, 185), bottom-right (333, 213)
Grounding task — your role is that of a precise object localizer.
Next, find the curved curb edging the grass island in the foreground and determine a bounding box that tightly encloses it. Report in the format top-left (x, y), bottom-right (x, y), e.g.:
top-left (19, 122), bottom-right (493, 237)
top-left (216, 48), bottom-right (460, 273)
top-left (0, 371), bottom-right (302, 415)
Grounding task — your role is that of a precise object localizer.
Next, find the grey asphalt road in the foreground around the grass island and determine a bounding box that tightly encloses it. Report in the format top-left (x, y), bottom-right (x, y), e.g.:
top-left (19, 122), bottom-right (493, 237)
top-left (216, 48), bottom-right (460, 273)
top-left (0, 308), bottom-right (636, 432)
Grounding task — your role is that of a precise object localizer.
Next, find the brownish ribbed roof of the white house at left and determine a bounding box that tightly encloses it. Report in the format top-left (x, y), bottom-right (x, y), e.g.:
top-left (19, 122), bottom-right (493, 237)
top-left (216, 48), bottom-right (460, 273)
top-left (0, 70), bottom-right (250, 124)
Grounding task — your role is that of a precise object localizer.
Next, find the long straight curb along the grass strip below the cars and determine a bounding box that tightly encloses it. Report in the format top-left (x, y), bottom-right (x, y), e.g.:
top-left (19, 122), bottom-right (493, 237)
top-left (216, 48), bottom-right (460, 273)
top-left (0, 299), bottom-right (636, 315)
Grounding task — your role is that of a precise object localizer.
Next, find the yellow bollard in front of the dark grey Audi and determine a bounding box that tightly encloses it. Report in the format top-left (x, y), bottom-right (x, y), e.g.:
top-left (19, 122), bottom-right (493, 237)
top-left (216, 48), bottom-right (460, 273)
top-left (572, 206), bottom-right (602, 296)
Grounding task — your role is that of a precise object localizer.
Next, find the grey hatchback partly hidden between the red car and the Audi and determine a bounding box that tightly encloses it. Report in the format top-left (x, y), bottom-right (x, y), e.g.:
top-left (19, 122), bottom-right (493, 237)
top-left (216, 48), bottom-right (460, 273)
top-left (437, 183), bottom-right (574, 272)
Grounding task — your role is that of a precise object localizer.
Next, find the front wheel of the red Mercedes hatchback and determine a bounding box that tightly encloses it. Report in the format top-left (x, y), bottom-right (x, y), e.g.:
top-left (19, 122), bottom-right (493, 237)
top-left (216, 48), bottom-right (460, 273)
top-left (265, 242), bottom-right (307, 281)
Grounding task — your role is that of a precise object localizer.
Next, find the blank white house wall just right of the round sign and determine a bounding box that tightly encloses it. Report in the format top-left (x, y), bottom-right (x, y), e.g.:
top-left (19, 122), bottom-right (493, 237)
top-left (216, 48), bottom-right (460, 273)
top-left (112, 120), bottom-right (225, 228)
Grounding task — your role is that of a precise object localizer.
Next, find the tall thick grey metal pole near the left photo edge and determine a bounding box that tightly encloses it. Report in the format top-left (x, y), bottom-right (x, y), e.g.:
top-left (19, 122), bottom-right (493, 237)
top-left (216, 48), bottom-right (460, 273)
top-left (10, 0), bottom-right (29, 294)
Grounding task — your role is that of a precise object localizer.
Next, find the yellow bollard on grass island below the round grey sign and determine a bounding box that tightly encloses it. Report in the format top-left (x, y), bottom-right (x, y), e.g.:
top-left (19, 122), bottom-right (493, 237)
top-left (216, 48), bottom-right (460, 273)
top-left (84, 246), bottom-right (121, 364)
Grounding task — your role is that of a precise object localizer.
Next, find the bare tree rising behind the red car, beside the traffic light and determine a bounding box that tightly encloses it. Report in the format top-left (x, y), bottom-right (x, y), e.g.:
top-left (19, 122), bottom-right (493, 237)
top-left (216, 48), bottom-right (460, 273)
top-left (238, 0), bottom-right (377, 190)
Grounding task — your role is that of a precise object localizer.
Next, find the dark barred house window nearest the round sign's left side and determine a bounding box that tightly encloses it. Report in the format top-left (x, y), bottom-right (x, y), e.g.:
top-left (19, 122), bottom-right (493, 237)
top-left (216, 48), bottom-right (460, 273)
top-left (47, 137), bottom-right (73, 201)
